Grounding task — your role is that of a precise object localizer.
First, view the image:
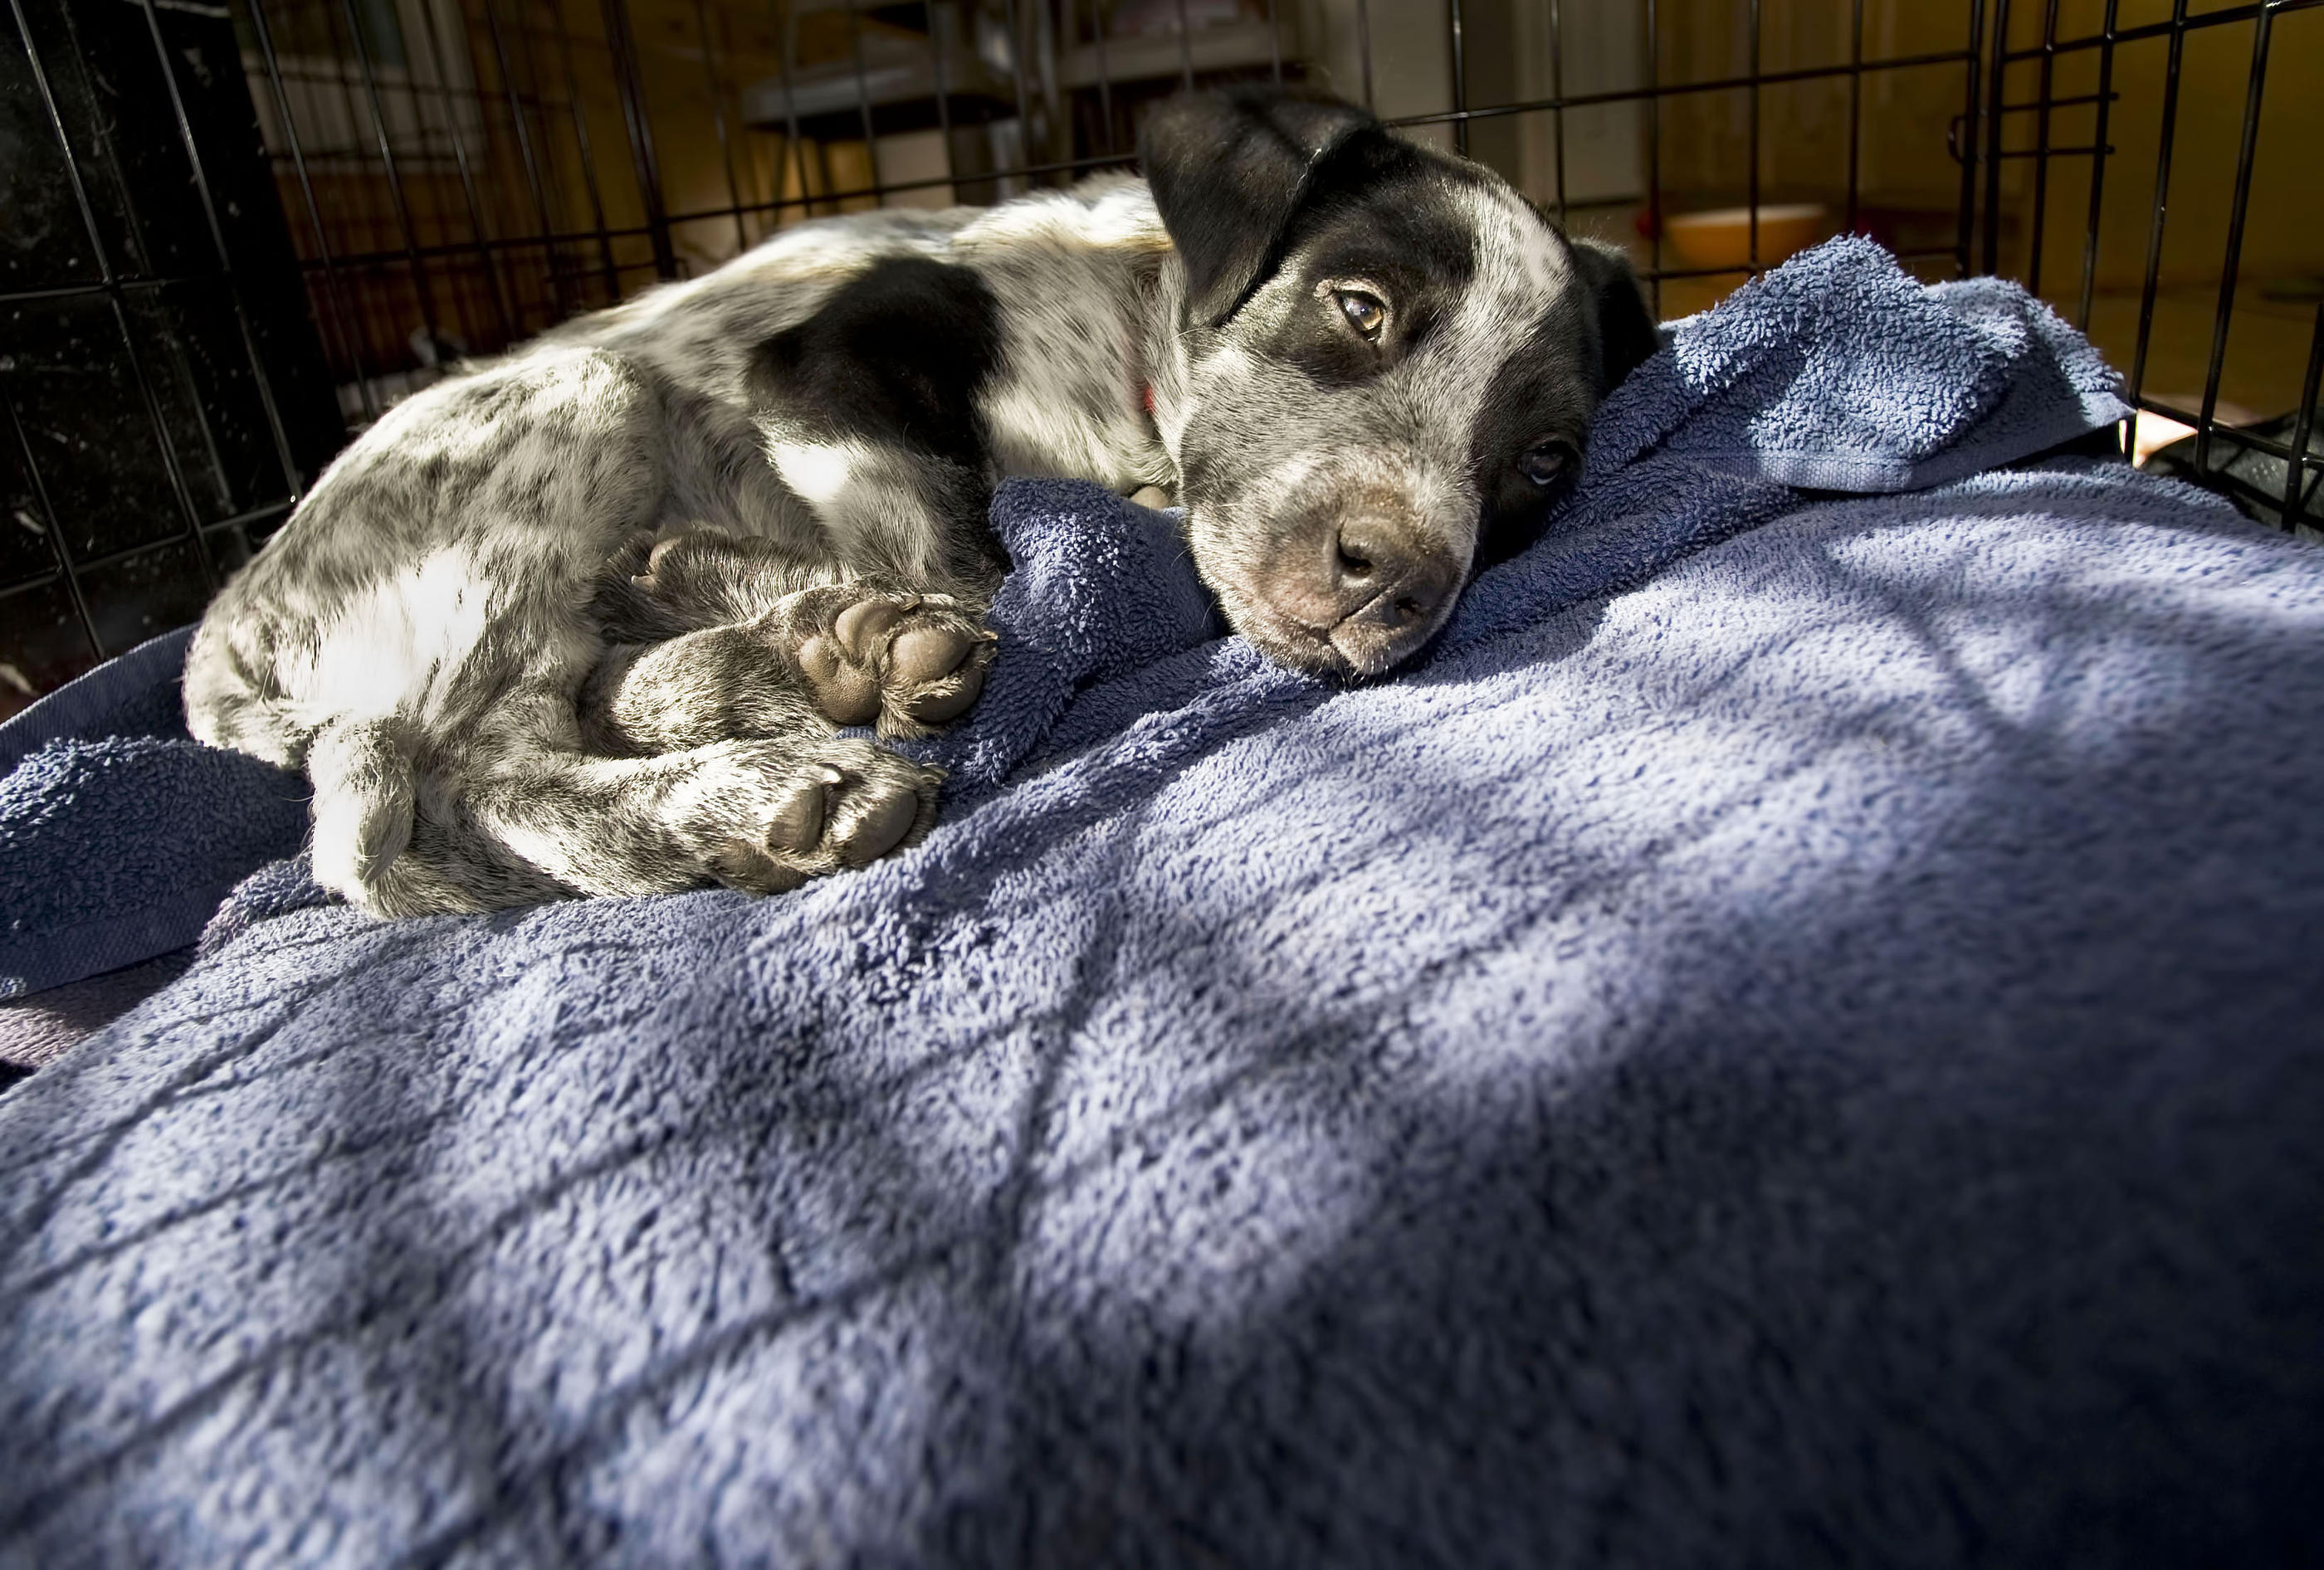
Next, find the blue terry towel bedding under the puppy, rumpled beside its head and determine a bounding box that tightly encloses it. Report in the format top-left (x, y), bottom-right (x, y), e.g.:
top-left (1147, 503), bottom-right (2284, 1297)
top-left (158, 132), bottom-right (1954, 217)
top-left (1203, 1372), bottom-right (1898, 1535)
top-left (0, 241), bottom-right (2324, 1565)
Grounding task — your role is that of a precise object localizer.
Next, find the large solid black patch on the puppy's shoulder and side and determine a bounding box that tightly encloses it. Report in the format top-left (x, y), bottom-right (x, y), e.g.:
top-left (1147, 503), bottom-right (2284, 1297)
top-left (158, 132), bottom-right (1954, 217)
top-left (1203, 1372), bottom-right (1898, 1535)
top-left (750, 256), bottom-right (999, 469)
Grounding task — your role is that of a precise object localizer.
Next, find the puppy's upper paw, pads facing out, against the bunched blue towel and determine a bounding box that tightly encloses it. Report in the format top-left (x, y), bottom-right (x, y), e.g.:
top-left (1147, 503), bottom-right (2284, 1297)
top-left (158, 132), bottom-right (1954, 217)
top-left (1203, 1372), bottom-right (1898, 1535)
top-left (779, 585), bottom-right (994, 736)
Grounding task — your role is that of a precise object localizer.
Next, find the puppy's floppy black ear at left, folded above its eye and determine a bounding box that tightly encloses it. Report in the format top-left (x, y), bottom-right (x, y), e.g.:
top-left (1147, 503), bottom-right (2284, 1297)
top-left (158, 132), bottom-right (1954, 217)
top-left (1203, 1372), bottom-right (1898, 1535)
top-left (1139, 88), bottom-right (1385, 328)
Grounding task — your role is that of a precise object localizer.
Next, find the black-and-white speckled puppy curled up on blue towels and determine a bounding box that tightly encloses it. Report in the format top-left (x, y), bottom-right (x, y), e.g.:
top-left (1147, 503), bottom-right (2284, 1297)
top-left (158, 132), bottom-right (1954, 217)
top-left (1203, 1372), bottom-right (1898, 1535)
top-left (186, 93), bottom-right (1657, 915)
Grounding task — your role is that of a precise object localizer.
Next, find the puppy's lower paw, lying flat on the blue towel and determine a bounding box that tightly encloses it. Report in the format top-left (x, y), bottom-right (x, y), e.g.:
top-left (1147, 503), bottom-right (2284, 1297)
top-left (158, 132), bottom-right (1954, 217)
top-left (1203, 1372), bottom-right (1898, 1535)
top-left (683, 736), bottom-right (944, 895)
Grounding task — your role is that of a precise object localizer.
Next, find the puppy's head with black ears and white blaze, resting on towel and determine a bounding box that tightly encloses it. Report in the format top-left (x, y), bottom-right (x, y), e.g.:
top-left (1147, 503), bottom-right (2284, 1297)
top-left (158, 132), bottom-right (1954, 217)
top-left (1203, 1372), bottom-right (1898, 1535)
top-left (1141, 93), bottom-right (1657, 675)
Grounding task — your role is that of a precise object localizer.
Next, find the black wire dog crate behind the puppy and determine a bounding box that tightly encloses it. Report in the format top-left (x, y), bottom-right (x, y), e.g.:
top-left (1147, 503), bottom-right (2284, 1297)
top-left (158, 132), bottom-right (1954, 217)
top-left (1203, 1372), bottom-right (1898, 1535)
top-left (0, 0), bottom-right (2324, 713)
